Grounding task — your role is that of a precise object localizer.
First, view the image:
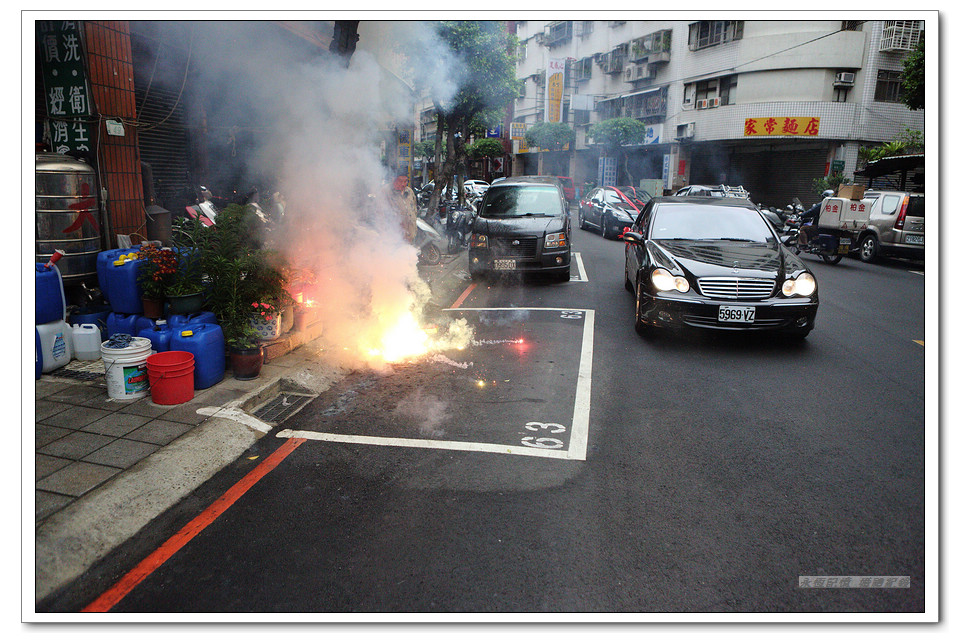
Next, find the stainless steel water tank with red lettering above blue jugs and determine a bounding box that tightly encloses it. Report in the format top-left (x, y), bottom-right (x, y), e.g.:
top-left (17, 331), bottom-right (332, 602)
top-left (36, 154), bottom-right (103, 280)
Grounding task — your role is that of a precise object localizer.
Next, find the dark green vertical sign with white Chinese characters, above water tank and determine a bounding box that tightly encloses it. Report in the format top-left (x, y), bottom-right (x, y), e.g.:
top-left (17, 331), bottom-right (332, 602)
top-left (37, 20), bottom-right (91, 154)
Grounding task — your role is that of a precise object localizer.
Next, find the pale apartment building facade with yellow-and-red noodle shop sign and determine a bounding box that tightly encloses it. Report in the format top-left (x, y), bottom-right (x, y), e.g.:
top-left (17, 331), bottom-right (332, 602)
top-left (510, 20), bottom-right (924, 205)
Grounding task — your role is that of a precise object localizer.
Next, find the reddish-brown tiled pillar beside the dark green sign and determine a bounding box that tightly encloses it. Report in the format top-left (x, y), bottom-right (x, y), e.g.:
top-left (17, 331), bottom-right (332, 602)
top-left (84, 21), bottom-right (146, 247)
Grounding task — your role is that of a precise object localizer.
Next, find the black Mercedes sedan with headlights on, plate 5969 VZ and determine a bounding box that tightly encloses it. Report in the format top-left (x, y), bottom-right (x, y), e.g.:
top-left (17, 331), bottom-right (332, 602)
top-left (623, 197), bottom-right (819, 338)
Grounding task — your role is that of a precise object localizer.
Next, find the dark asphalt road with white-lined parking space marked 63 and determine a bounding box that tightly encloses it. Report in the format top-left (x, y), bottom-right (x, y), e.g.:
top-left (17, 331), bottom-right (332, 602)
top-left (46, 225), bottom-right (936, 618)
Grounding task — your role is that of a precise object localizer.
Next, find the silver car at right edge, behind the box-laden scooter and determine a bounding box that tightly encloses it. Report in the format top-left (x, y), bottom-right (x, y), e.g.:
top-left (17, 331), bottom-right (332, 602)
top-left (860, 190), bottom-right (924, 262)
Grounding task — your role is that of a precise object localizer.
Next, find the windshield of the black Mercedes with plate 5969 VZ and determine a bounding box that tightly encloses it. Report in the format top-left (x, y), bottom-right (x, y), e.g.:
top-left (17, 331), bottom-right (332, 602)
top-left (650, 203), bottom-right (774, 243)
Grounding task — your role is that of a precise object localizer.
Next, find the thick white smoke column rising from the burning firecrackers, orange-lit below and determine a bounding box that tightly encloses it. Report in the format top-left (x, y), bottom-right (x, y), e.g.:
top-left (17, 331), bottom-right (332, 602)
top-left (180, 21), bottom-right (463, 365)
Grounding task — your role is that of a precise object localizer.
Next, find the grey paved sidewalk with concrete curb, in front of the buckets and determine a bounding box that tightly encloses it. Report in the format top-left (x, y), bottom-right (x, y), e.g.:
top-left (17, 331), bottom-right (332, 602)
top-left (35, 252), bottom-right (470, 602)
